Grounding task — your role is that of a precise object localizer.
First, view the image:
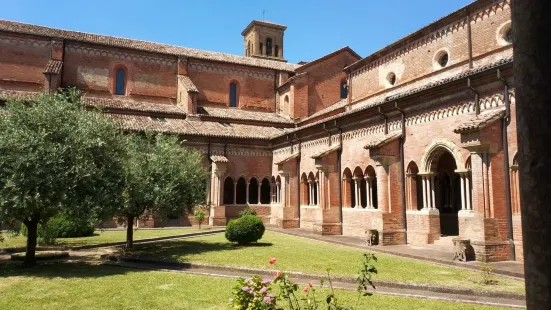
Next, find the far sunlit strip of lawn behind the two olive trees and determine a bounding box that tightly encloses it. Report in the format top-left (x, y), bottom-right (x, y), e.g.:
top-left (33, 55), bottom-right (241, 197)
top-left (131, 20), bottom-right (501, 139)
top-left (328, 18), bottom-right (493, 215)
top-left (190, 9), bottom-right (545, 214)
top-left (0, 228), bottom-right (210, 249)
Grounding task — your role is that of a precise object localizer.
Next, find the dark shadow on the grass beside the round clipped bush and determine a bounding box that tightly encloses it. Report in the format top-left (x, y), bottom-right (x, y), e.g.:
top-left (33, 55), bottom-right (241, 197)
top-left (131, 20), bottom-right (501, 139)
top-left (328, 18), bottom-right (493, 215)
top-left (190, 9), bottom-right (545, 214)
top-left (120, 240), bottom-right (273, 262)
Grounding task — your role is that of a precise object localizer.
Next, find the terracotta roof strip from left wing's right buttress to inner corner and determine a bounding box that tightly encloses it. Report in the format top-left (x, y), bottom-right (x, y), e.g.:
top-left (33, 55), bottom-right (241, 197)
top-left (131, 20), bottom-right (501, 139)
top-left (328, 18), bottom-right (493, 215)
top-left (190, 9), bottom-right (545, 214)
top-left (198, 106), bottom-right (293, 124)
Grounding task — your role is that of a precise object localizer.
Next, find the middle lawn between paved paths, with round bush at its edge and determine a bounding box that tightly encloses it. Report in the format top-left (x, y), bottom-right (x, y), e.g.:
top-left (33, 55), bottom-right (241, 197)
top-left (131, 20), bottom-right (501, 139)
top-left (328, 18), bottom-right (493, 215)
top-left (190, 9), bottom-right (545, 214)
top-left (129, 231), bottom-right (524, 292)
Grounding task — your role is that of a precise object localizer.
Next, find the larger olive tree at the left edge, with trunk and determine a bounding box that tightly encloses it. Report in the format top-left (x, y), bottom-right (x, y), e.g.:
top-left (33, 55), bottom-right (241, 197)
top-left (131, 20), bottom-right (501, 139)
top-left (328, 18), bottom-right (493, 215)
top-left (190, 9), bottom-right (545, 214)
top-left (0, 90), bottom-right (125, 266)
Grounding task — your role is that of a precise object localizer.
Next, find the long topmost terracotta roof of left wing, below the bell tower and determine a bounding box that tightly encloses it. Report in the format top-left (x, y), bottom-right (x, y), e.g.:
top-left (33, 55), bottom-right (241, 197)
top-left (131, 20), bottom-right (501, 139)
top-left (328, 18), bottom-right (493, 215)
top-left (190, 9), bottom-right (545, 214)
top-left (0, 20), bottom-right (298, 72)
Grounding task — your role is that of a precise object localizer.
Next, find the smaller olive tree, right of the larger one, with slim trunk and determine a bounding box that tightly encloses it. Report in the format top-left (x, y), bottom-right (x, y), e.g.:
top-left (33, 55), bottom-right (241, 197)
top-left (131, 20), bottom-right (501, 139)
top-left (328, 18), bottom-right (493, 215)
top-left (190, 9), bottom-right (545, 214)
top-left (117, 133), bottom-right (208, 249)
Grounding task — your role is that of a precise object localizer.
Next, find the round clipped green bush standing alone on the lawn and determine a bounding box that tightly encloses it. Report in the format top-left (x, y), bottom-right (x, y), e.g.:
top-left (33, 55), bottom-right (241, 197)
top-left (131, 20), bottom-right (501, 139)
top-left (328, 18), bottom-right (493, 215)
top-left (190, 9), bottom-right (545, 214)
top-left (226, 215), bottom-right (266, 245)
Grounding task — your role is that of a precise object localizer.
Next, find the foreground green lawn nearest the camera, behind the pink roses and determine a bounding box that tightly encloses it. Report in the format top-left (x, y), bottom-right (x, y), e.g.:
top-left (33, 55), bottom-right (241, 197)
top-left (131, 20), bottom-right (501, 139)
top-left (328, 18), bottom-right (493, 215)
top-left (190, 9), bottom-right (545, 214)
top-left (0, 264), bottom-right (505, 310)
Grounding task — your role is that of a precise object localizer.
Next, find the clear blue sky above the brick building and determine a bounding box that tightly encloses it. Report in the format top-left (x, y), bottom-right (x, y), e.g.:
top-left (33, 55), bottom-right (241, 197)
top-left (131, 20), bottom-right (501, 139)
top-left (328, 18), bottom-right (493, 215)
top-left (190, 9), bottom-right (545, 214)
top-left (0, 0), bottom-right (472, 63)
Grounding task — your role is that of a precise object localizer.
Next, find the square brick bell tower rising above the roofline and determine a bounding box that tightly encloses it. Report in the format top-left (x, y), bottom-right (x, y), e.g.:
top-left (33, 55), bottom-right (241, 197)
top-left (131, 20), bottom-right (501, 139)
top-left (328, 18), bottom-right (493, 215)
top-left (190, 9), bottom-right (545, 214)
top-left (241, 20), bottom-right (287, 61)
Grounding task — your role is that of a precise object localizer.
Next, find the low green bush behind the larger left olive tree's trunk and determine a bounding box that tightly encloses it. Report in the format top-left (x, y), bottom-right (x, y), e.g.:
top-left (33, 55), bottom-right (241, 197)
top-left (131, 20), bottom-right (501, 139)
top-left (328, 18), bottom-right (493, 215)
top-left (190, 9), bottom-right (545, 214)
top-left (21, 216), bottom-right (94, 244)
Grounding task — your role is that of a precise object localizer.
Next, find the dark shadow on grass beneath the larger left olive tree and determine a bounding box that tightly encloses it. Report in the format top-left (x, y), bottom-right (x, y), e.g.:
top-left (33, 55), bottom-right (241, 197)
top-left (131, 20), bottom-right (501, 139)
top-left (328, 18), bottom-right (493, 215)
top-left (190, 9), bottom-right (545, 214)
top-left (0, 263), bottom-right (142, 281)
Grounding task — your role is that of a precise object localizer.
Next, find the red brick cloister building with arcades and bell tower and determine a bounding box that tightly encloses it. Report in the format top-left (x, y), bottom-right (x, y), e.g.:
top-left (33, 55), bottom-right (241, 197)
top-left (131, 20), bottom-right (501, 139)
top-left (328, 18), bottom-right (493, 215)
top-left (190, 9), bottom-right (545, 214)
top-left (0, 0), bottom-right (523, 260)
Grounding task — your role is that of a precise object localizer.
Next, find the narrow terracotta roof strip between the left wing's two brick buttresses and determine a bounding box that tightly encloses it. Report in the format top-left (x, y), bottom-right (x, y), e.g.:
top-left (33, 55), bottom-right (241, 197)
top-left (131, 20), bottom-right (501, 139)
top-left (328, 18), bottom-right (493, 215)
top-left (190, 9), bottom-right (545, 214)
top-left (82, 96), bottom-right (186, 116)
